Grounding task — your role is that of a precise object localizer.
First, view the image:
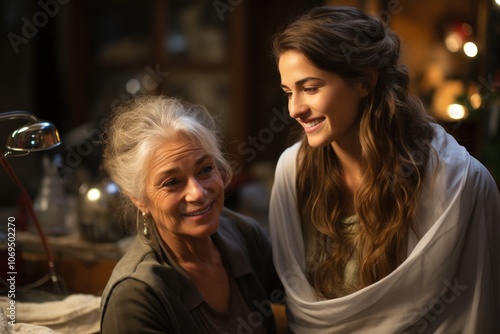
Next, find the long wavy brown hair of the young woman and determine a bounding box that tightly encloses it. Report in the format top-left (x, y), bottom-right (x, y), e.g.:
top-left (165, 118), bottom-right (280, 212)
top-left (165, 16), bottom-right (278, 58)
top-left (273, 6), bottom-right (434, 298)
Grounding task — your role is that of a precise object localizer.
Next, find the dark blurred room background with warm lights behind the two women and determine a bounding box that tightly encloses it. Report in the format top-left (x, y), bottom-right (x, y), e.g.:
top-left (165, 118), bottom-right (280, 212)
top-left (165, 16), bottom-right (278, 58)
top-left (0, 0), bottom-right (500, 293)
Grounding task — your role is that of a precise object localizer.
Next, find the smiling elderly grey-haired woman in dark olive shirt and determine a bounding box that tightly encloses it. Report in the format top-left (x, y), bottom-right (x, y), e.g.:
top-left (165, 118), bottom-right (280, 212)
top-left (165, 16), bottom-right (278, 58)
top-left (101, 96), bottom-right (283, 334)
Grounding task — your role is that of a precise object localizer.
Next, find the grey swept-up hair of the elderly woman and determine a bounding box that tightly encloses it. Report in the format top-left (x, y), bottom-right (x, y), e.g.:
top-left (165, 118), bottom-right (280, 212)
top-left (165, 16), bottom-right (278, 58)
top-left (102, 95), bottom-right (233, 206)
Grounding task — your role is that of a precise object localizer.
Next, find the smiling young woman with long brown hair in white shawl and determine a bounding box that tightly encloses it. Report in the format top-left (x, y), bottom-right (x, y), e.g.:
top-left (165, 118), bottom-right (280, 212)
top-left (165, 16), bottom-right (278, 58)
top-left (270, 7), bottom-right (500, 333)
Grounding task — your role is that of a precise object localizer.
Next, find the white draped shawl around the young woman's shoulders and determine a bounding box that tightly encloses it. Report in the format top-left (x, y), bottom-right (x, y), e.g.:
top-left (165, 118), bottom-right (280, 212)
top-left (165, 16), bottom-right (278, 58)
top-left (269, 125), bottom-right (500, 334)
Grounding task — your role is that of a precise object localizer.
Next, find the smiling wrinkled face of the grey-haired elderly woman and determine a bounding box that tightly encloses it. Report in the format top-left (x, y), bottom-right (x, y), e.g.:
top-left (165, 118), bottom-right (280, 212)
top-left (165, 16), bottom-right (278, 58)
top-left (141, 137), bottom-right (224, 242)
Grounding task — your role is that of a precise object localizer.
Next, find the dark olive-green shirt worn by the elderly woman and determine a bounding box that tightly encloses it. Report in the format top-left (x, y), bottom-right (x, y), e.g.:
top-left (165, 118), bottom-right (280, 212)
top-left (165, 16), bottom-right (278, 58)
top-left (101, 209), bottom-right (284, 334)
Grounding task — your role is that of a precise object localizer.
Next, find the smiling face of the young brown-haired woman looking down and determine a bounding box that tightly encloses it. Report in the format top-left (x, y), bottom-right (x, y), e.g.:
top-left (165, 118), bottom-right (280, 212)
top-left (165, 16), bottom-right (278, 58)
top-left (278, 51), bottom-right (367, 147)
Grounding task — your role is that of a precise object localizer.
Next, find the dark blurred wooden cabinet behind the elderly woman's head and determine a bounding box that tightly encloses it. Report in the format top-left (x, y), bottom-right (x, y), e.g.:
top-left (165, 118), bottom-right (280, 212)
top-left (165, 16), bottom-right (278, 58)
top-left (67, 0), bottom-right (245, 158)
